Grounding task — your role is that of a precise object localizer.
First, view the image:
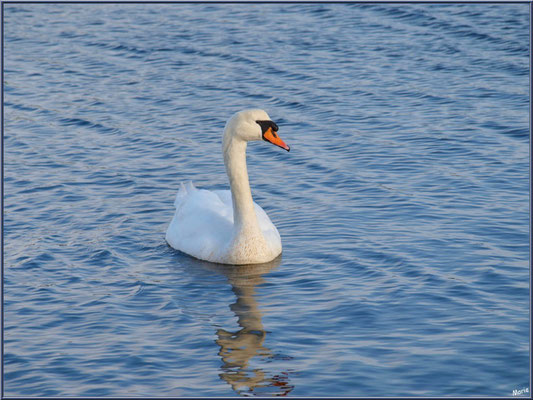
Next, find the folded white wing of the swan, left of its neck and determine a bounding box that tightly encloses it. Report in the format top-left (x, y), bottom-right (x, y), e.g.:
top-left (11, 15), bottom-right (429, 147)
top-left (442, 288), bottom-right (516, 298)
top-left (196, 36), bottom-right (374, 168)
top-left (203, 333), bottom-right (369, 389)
top-left (166, 184), bottom-right (233, 259)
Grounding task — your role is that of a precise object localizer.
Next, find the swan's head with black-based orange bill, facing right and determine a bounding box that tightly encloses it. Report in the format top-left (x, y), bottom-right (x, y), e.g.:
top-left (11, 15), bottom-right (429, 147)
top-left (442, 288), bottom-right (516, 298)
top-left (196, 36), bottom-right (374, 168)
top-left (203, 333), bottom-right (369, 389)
top-left (224, 110), bottom-right (290, 151)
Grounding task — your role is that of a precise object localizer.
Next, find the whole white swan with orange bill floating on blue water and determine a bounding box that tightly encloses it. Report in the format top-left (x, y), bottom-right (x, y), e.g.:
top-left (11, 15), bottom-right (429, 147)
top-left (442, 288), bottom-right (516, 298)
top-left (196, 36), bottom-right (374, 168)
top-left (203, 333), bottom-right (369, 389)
top-left (165, 110), bottom-right (290, 265)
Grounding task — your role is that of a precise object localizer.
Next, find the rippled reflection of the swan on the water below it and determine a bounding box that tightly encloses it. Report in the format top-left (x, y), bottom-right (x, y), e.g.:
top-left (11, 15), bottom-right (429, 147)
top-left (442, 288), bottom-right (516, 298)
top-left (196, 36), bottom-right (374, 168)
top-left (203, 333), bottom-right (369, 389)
top-left (198, 256), bottom-right (294, 396)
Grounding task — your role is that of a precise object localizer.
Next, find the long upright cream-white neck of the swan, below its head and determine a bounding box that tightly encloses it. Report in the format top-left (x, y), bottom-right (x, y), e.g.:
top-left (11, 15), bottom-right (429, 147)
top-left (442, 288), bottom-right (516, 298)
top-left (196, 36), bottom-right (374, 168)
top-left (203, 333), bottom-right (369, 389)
top-left (224, 137), bottom-right (260, 234)
